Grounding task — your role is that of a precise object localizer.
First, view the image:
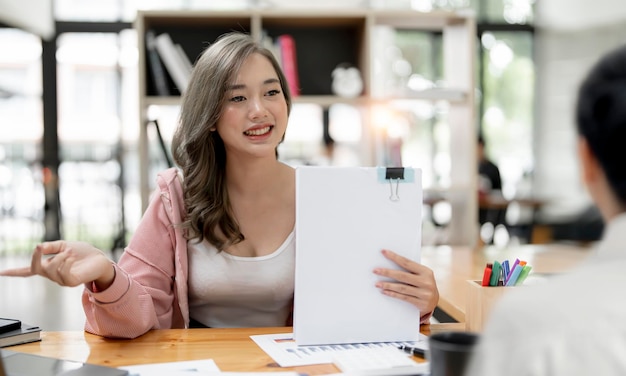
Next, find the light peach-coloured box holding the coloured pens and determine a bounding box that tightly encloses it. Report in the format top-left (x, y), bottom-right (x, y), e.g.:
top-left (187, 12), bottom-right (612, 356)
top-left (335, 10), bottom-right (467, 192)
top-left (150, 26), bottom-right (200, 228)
top-left (465, 280), bottom-right (516, 332)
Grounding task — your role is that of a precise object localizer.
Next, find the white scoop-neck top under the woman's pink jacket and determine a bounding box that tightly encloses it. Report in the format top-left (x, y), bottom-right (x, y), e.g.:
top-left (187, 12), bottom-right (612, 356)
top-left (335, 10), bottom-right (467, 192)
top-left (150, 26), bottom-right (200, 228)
top-left (187, 231), bottom-right (296, 328)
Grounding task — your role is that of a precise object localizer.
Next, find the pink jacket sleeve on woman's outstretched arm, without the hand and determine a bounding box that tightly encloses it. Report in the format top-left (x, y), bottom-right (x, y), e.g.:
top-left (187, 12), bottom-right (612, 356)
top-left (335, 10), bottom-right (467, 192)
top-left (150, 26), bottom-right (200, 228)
top-left (83, 187), bottom-right (175, 338)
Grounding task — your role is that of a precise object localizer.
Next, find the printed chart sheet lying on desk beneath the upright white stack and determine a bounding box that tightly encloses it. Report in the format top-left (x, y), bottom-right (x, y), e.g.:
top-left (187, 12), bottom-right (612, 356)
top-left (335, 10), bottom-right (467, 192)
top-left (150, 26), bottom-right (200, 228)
top-left (250, 333), bottom-right (428, 367)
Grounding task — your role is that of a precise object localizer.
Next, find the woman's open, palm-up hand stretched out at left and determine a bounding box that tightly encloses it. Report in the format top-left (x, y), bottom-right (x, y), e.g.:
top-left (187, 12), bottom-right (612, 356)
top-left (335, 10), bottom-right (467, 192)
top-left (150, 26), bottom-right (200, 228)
top-left (0, 240), bottom-right (115, 291)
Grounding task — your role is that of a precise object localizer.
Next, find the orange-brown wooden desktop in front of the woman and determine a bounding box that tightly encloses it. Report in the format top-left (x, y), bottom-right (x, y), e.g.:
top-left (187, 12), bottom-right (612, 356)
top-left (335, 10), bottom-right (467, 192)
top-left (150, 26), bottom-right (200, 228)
top-left (6, 324), bottom-right (464, 375)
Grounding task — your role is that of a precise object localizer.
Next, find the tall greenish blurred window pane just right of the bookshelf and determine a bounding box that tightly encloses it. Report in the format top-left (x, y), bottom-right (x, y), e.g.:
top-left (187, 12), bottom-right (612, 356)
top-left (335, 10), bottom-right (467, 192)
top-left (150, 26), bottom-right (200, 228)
top-left (481, 32), bottom-right (535, 196)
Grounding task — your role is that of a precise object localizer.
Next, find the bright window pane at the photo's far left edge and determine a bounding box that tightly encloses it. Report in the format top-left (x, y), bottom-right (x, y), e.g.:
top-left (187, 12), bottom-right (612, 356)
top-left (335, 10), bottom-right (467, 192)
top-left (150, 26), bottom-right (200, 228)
top-left (0, 28), bottom-right (44, 254)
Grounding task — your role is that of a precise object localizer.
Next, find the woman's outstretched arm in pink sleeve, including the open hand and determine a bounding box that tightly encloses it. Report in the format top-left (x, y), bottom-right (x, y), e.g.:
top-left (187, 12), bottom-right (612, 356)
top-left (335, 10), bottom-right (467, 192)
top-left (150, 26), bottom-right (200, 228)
top-left (0, 172), bottom-right (186, 338)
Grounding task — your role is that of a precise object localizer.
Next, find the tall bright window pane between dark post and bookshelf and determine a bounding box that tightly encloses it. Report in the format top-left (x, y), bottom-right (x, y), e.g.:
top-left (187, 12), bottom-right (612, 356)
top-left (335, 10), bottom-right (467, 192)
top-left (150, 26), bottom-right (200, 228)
top-left (56, 31), bottom-right (140, 250)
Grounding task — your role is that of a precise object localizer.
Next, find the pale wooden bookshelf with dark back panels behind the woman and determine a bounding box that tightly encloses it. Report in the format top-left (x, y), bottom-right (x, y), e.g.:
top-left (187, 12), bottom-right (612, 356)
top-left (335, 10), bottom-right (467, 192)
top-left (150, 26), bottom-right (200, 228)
top-left (135, 7), bottom-right (478, 246)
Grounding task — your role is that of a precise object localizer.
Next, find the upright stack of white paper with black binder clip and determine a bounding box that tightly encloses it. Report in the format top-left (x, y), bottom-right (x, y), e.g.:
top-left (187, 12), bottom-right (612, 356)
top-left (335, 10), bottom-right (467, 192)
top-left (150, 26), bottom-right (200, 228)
top-left (294, 166), bottom-right (422, 345)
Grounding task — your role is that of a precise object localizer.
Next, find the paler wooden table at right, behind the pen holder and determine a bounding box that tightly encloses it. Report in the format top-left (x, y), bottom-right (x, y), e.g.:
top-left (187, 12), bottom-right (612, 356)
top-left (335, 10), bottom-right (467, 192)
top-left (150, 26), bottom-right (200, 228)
top-left (421, 244), bottom-right (592, 322)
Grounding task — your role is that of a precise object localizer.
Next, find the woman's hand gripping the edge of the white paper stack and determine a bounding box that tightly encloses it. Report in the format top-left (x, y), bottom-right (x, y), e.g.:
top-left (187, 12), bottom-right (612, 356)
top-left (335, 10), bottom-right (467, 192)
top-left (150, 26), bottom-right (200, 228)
top-left (374, 249), bottom-right (439, 324)
